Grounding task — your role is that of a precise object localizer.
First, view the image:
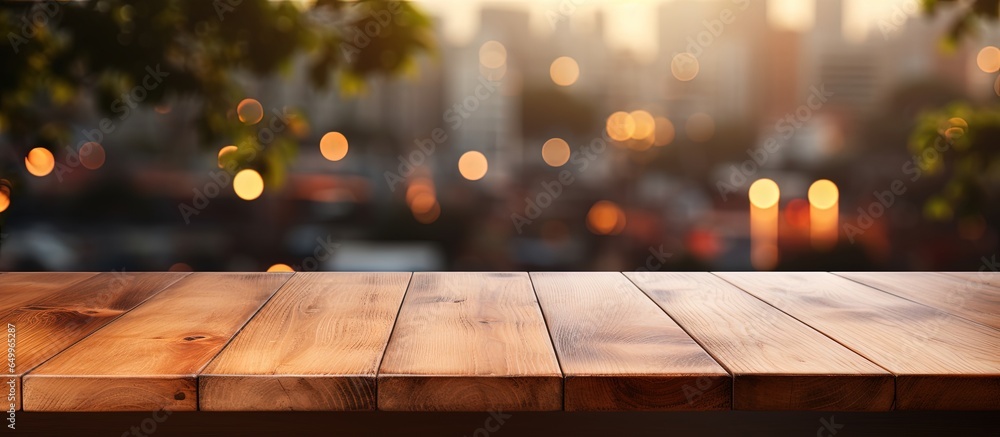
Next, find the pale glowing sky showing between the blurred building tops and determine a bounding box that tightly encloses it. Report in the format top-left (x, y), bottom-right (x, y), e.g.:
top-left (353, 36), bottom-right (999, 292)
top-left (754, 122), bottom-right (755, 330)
top-left (417, 0), bottom-right (920, 60)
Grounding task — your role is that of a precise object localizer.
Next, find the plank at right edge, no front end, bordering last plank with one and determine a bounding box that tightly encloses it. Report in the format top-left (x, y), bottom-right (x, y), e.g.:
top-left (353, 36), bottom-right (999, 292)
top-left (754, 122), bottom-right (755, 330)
top-left (834, 272), bottom-right (1000, 328)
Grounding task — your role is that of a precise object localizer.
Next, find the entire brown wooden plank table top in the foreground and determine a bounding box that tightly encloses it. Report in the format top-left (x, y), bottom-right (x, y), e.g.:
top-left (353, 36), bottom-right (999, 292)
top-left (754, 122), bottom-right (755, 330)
top-left (0, 272), bottom-right (1000, 412)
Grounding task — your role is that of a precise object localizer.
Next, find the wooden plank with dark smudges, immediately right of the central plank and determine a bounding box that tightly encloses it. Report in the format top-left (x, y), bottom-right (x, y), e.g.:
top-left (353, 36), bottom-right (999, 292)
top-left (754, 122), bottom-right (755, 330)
top-left (531, 273), bottom-right (732, 411)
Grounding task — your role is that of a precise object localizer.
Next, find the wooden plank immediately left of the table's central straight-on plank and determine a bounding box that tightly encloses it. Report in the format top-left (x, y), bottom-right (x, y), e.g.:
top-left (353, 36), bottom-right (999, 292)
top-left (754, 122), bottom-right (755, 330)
top-left (198, 273), bottom-right (410, 411)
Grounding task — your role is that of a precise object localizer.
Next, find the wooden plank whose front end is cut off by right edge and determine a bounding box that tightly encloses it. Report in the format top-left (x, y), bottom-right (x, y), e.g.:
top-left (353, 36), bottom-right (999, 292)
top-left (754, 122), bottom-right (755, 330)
top-left (717, 273), bottom-right (1000, 410)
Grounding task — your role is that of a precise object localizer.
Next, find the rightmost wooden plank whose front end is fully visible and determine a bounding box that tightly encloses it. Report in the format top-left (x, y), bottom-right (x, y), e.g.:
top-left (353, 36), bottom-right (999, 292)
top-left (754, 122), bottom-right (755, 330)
top-left (626, 272), bottom-right (895, 411)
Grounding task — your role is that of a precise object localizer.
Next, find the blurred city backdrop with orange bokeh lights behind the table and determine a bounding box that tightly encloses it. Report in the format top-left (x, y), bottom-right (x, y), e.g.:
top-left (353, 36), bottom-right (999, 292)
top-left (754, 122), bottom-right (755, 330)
top-left (0, 0), bottom-right (1000, 270)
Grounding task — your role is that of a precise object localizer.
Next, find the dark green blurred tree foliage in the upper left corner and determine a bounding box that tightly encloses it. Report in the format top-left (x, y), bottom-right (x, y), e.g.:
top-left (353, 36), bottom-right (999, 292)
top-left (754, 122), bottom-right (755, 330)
top-left (0, 0), bottom-right (433, 183)
